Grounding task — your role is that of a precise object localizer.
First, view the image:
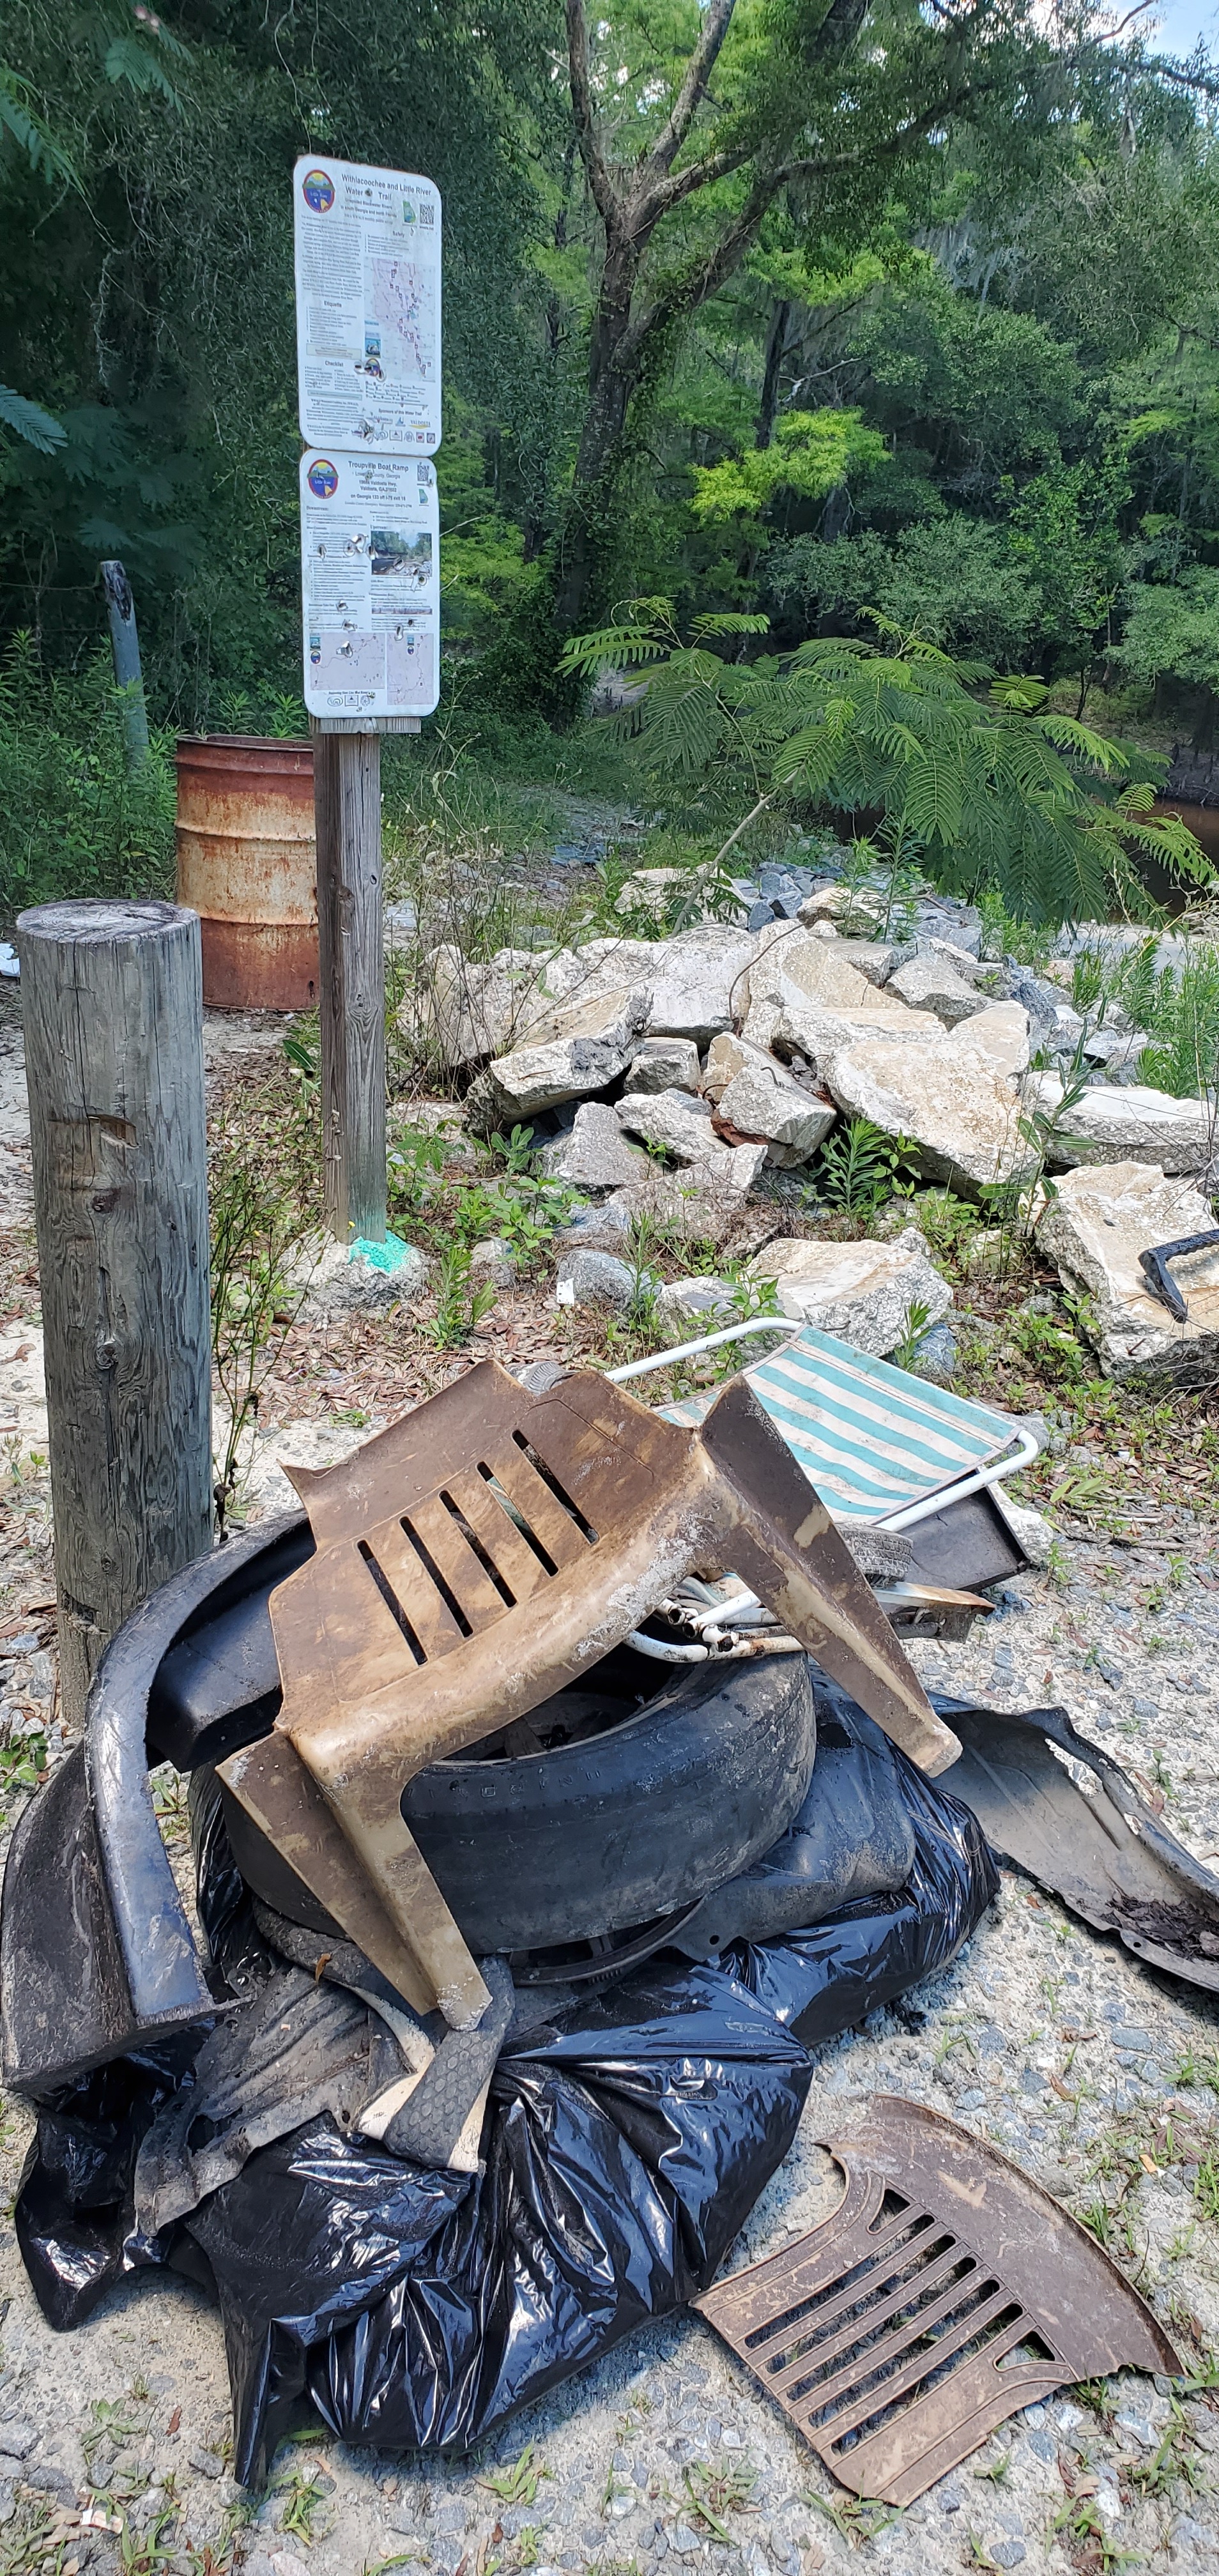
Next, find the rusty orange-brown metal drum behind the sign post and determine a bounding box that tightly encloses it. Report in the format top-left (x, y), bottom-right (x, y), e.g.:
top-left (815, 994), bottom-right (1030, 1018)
top-left (178, 734), bottom-right (317, 1010)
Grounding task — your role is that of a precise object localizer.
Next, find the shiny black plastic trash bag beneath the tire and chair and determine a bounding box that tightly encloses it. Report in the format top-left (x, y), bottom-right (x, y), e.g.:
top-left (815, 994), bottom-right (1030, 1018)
top-left (15, 1677), bottom-right (997, 2483)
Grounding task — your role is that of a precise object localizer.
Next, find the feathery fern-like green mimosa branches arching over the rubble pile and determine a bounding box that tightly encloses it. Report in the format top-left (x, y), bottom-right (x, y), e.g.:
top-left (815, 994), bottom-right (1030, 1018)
top-left (567, 606), bottom-right (1211, 922)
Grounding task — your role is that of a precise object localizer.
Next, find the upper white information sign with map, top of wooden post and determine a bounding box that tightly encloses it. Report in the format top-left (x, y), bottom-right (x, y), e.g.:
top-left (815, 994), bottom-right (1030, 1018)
top-left (294, 155), bottom-right (441, 456)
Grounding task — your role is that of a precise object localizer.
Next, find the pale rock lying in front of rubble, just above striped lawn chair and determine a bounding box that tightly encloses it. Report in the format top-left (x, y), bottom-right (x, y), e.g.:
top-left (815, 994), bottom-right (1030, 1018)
top-left (750, 1226), bottom-right (954, 1360)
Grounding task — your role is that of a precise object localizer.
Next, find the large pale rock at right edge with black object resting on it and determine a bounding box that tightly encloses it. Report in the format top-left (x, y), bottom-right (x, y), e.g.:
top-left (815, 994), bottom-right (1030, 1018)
top-left (1036, 1162), bottom-right (1219, 1386)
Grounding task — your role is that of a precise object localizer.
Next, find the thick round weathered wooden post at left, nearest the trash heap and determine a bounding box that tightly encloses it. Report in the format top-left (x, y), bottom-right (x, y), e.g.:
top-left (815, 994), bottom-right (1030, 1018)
top-left (18, 901), bottom-right (211, 1723)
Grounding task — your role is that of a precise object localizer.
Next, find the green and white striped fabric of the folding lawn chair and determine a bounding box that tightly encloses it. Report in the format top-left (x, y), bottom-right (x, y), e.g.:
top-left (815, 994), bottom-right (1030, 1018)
top-left (660, 1324), bottom-right (1015, 1520)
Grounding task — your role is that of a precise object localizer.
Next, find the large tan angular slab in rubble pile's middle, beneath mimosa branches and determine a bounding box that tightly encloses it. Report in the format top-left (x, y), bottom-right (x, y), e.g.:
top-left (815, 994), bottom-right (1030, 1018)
top-left (830, 1023), bottom-right (1031, 1198)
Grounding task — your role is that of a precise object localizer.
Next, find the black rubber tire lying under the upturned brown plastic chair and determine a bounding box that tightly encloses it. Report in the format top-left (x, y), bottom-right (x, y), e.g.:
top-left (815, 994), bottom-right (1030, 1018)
top-left (224, 1648), bottom-right (817, 1958)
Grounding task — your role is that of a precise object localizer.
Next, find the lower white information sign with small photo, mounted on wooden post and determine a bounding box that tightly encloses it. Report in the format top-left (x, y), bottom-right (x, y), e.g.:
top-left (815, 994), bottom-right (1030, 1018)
top-left (302, 448), bottom-right (441, 716)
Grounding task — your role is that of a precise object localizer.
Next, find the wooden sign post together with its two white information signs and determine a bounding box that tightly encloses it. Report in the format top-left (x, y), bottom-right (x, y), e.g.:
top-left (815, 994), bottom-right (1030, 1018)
top-left (294, 160), bottom-right (441, 1244)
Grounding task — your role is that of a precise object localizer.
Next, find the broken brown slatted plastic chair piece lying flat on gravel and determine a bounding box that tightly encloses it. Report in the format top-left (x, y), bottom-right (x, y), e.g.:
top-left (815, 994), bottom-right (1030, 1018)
top-left (693, 2097), bottom-right (1180, 2504)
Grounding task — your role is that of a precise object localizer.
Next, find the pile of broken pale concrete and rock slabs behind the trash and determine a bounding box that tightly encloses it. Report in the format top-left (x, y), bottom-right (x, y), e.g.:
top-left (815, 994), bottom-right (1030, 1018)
top-left (404, 868), bottom-right (1214, 1383)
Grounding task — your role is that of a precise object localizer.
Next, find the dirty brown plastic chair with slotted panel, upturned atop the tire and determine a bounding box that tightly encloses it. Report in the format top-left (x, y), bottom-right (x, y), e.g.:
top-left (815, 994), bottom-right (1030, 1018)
top-left (219, 1360), bottom-right (959, 2027)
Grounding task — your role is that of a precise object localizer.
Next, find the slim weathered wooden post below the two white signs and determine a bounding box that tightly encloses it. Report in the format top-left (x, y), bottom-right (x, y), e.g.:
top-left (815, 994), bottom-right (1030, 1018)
top-left (314, 726), bottom-right (384, 1244)
